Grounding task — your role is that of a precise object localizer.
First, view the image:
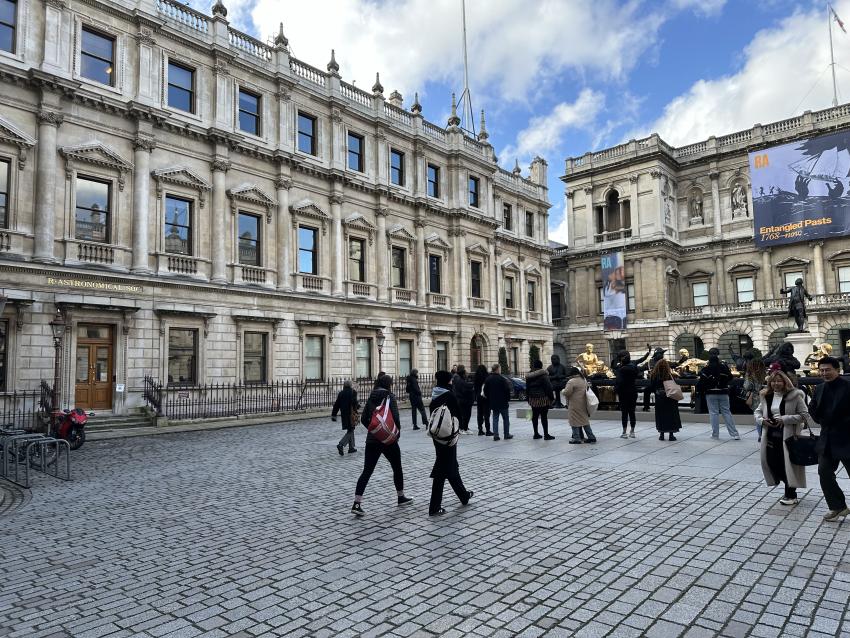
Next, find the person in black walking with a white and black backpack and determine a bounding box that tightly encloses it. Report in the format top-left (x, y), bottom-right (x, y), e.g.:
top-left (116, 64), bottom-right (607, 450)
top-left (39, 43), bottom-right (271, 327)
top-left (428, 370), bottom-right (473, 516)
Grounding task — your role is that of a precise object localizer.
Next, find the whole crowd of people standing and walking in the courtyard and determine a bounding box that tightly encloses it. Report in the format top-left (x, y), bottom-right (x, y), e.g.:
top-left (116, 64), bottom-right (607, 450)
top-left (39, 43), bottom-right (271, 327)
top-left (332, 347), bottom-right (850, 521)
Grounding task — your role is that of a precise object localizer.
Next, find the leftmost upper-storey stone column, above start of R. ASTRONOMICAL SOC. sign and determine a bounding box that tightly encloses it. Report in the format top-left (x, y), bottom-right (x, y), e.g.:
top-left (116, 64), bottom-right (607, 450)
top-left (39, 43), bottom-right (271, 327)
top-left (32, 110), bottom-right (65, 262)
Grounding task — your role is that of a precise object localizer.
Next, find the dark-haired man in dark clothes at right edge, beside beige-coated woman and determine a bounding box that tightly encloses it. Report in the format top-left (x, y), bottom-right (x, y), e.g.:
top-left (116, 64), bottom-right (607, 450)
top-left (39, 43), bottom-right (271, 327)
top-left (809, 357), bottom-right (850, 521)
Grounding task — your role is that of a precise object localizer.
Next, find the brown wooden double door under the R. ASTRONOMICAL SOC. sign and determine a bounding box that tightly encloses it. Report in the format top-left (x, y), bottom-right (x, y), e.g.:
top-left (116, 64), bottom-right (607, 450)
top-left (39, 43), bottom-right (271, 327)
top-left (74, 324), bottom-right (115, 410)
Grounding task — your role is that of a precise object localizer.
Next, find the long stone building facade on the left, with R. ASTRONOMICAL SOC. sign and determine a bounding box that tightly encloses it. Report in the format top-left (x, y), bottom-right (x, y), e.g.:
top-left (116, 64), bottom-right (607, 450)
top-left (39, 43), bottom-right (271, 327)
top-left (0, 0), bottom-right (552, 412)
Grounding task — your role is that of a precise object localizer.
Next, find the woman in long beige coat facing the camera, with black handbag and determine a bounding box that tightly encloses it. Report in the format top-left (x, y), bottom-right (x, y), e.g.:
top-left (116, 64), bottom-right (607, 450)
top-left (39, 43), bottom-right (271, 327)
top-left (755, 371), bottom-right (811, 505)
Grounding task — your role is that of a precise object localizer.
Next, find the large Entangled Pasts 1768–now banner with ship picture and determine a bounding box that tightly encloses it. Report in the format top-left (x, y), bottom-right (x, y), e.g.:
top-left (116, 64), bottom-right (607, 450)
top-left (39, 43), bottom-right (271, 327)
top-left (749, 131), bottom-right (850, 247)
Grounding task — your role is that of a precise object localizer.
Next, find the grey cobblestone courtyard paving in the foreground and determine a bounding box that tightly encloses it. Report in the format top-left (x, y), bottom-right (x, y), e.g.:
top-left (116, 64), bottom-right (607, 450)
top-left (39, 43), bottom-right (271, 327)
top-left (0, 414), bottom-right (850, 638)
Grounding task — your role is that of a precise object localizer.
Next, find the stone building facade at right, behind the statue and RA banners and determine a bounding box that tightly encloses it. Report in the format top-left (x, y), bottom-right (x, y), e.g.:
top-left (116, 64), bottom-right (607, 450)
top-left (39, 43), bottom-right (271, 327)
top-left (552, 105), bottom-right (850, 370)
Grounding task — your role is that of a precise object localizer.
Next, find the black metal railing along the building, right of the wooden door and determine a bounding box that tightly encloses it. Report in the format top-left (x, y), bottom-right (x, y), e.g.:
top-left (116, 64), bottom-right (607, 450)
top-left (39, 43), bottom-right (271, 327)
top-left (144, 374), bottom-right (434, 421)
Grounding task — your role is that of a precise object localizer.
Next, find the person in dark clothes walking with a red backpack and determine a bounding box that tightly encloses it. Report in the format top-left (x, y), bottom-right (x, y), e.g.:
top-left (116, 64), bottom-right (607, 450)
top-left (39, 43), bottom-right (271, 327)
top-left (351, 374), bottom-right (413, 516)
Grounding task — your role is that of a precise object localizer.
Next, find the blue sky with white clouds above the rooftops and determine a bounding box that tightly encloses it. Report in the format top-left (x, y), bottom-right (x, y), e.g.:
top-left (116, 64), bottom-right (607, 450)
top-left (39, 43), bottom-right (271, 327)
top-left (214, 0), bottom-right (850, 241)
